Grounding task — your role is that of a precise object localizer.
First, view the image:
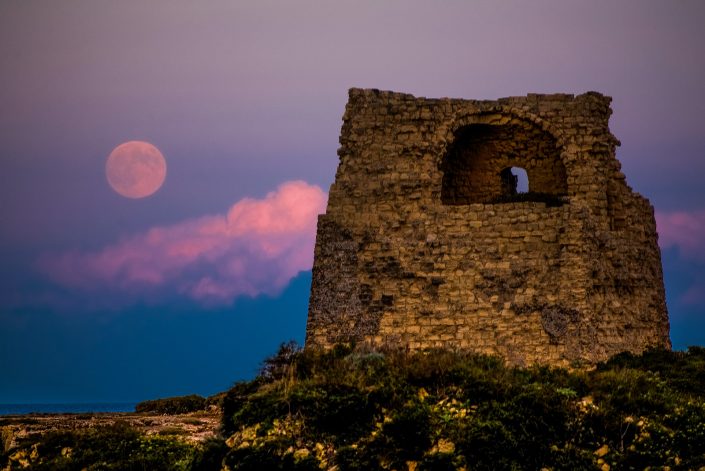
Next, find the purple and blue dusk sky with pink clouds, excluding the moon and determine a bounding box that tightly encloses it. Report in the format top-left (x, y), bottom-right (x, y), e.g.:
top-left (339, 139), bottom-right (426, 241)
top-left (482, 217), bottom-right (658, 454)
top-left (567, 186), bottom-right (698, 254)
top-left (0, 0), bottom-right (705, 402)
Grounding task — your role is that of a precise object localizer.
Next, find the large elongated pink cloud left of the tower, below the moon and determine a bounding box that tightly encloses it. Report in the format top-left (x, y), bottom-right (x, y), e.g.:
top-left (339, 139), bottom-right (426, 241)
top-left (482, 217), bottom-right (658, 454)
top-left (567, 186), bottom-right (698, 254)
top-left (39, 181), bottom-right (327, 304)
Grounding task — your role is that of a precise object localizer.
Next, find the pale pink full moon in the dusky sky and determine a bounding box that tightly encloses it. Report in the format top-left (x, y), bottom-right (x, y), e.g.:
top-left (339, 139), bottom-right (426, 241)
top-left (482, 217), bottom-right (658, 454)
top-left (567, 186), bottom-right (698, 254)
top-left (105, 141), bottom-right (166, 198)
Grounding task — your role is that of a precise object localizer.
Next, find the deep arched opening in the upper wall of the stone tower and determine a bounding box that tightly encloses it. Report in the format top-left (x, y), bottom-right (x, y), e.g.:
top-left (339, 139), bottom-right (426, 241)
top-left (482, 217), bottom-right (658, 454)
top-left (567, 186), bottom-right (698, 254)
top-left (441, 121), bottom-right (568, 205)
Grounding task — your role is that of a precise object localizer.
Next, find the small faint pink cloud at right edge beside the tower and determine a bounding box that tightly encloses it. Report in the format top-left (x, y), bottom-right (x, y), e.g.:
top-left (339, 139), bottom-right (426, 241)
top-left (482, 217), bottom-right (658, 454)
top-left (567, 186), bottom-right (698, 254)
top-left (656, 210), bottom-right (705, 261)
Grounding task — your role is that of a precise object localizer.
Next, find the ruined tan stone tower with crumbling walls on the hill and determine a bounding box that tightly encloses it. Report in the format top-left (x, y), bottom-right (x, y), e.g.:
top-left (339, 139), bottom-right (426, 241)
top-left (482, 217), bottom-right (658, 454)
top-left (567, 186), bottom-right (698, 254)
top-left (306, 89), bottom-right (670, 365)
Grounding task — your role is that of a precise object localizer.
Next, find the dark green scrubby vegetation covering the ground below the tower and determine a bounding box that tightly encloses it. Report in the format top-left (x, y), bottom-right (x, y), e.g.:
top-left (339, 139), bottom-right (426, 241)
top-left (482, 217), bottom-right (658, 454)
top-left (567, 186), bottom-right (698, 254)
top-left (5, 343), bottom-right (705, 471)
